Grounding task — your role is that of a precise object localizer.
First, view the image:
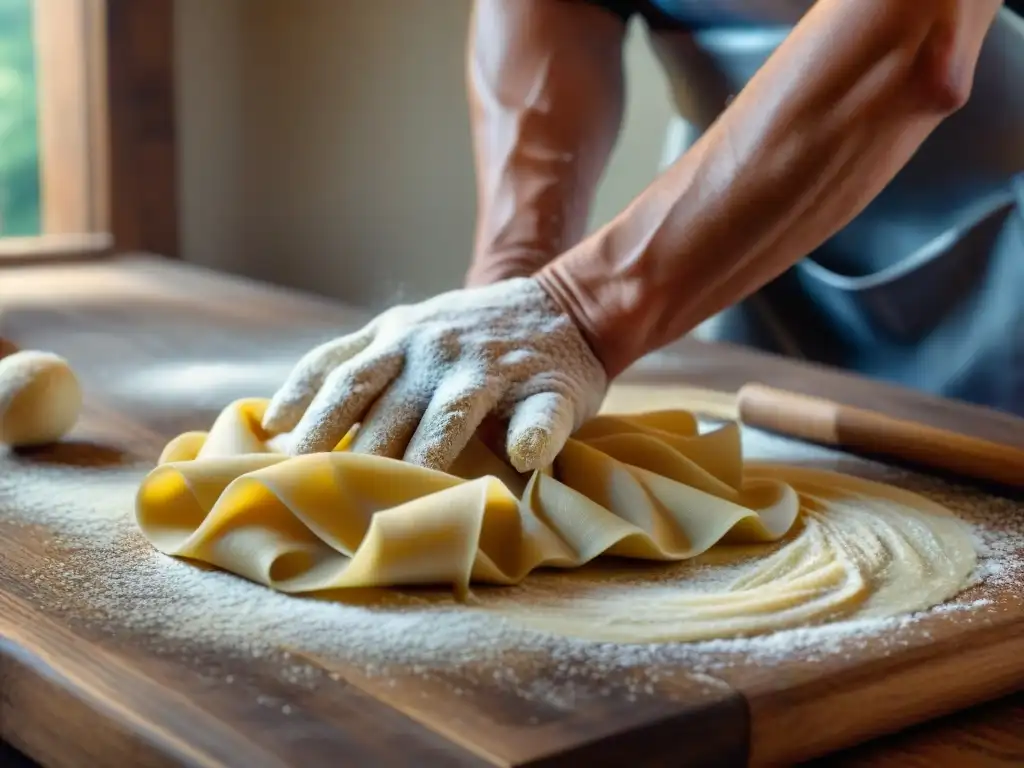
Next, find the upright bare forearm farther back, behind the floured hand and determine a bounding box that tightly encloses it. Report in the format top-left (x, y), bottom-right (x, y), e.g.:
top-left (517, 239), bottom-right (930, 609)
top-left (466, 0), bottom-right (625, 285)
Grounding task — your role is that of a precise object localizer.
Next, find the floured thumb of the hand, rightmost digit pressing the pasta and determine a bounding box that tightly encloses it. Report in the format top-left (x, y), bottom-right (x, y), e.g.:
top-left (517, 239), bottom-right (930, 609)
top-left (506, 392), bottom-right (574, 472)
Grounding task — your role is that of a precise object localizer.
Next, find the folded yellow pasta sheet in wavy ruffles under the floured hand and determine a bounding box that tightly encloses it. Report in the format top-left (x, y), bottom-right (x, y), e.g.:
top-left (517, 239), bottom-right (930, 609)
top-left (136, 398), bottom-right (801, 593)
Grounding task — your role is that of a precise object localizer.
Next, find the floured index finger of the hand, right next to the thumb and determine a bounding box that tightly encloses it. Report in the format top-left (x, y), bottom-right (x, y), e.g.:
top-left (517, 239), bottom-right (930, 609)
top-left (404, 374), bottom-right (501, 471)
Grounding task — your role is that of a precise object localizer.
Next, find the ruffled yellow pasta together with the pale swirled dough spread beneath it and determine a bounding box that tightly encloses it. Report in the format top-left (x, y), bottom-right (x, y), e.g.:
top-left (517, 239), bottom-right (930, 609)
top-left (136, 399), bottom-right (975, 641)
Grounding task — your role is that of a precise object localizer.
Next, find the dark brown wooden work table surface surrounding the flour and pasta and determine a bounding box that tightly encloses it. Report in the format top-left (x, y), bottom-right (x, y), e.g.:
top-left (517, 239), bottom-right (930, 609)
top-left (0, 259), bottom-right (1024, 766)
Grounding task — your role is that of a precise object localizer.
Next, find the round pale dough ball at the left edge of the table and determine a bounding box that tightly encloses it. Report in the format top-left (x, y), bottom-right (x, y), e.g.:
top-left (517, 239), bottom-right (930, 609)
top-left (0, 350), bottom-right (82, 446)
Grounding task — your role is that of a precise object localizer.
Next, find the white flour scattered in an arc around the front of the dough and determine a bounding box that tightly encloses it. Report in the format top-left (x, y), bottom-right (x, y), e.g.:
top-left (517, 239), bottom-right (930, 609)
top-left (0, 423), bottom-right (1024, 700)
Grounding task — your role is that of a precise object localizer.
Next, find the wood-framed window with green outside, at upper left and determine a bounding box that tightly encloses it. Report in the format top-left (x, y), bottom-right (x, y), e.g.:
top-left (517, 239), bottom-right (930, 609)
top-left (0, 0), bottom-right (177, 259)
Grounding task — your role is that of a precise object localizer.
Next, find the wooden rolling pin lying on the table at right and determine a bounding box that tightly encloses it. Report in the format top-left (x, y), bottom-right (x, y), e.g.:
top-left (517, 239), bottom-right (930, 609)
top-left (671, 384), bottom-right (1024, 487)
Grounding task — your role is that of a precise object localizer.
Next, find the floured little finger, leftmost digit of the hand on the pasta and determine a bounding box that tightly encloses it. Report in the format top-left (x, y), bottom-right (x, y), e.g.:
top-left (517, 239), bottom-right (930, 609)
top-left (262, 322), bottom-right (377, 434)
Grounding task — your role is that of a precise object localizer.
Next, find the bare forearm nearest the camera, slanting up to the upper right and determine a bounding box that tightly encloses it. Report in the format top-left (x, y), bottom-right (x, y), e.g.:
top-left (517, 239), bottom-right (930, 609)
top-left (539, 0), bottom-right (999, 376)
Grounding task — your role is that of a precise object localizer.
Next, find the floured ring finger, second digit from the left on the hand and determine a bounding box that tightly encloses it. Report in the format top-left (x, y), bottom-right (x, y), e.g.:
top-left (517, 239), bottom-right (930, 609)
top-left (292, 347), bottom-right (404, 454)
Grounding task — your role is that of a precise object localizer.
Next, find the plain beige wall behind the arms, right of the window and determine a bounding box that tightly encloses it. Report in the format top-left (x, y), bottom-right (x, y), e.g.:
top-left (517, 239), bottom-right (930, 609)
top-left (177, 0), bottom-right (669, 306)
